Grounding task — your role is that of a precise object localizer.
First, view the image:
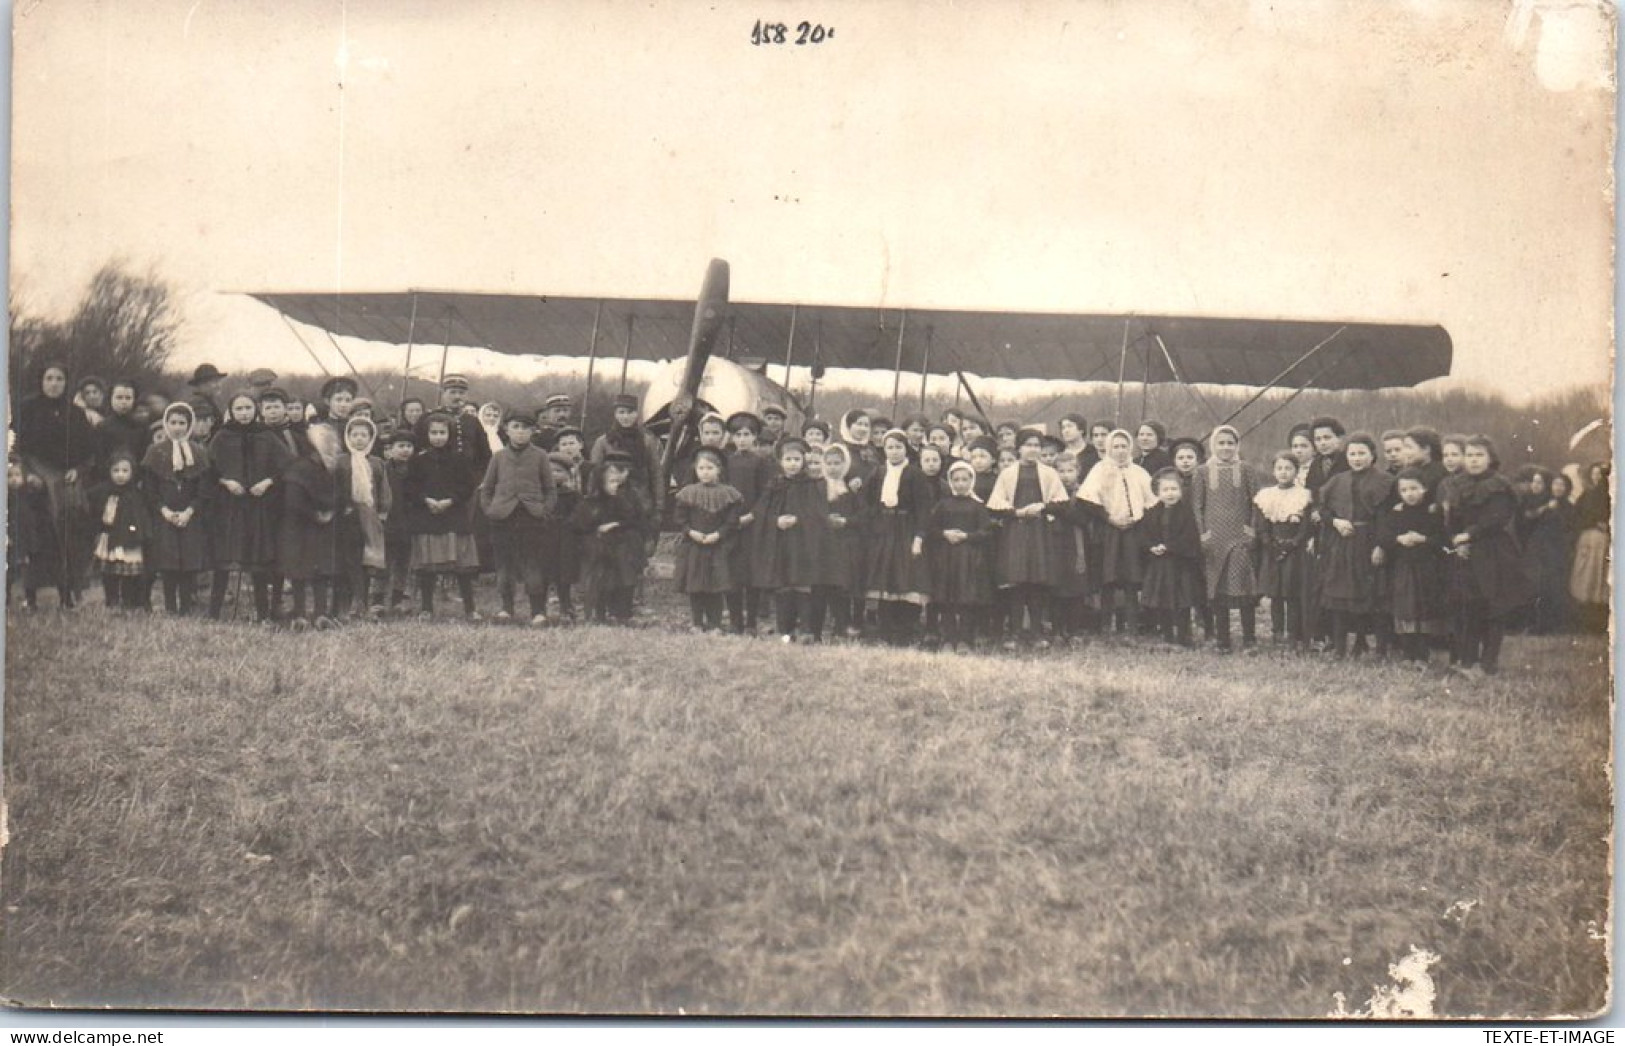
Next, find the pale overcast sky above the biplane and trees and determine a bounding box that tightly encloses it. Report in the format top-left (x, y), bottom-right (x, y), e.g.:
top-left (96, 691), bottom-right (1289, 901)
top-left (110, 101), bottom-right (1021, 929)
top-left (11, 0), bottom-right (1614, 395)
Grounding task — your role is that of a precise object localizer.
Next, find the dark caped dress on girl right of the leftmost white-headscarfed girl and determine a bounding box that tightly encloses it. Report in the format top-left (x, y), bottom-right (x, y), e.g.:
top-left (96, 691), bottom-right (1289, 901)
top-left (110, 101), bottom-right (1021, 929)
top-left (208, 421), bottom-right (293, 570)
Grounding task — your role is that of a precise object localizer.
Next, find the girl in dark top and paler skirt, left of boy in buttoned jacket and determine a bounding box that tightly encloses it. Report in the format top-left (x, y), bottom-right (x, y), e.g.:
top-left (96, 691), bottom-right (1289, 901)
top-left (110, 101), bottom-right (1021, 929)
top-left (406, 411), bottom-right (479, 620)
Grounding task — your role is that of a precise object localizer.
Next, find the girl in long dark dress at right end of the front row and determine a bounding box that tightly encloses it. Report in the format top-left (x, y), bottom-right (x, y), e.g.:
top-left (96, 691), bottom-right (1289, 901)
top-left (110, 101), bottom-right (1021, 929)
top-left (1445, 435), bottom-right (1531, 679)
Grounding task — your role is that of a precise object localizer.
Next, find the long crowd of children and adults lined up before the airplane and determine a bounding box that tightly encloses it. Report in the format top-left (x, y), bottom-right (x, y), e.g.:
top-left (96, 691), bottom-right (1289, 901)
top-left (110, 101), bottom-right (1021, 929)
top-left (7, 364), bottom-right (1610, 676)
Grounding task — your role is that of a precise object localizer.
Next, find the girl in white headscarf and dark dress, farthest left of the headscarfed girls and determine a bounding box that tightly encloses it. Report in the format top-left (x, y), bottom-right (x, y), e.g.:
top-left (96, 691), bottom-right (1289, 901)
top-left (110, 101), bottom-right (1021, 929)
top-left (141, 403), bottom-right (213, 614)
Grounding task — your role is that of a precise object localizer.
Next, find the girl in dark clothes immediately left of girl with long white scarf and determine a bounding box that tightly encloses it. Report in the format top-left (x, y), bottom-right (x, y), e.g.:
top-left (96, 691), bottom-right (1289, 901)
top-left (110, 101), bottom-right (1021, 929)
top-left (276, 426), bottom-right (340, 632)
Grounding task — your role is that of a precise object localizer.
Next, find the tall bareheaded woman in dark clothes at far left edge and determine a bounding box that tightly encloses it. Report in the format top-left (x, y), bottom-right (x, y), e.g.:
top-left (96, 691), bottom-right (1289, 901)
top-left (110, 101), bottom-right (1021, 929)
top-left (15, 364), bottom-right (96, 607)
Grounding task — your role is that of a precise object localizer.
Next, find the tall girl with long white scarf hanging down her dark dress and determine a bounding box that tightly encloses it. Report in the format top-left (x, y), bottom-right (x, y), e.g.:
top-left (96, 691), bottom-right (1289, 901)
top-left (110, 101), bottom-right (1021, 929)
top-left (863, 429), bottom-right (929, 646)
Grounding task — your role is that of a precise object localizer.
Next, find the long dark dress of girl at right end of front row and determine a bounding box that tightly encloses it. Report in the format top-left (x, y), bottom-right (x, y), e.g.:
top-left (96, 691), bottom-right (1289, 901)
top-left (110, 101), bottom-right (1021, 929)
top-left (1445, 473), bottom-right (1532, 619)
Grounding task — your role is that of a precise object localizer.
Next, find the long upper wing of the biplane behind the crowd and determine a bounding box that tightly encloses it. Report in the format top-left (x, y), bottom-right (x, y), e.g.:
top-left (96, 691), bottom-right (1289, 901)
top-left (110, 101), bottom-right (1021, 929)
top-left (252, 291), bottom-right (1451, 388)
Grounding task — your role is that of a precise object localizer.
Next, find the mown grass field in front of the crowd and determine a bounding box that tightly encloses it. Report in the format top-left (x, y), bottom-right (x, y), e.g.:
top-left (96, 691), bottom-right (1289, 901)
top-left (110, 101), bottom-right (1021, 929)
top-left (0, 609), bottom-right (1612, 1017)
